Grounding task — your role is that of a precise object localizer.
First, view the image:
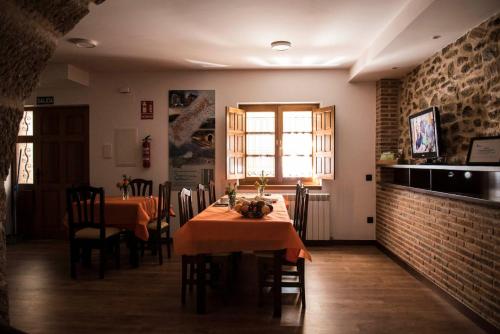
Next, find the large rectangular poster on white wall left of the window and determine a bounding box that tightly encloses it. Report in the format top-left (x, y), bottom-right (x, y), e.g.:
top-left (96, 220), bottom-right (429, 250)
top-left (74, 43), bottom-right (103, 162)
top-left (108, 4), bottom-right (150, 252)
top-left (168, 90), bottom-right (215, 190)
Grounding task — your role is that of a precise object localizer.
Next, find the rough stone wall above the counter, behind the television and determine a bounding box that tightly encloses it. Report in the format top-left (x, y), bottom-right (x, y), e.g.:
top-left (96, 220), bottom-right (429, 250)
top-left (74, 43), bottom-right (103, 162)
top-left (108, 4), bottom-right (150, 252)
top-left (399, 14), bottom-right (500, 163)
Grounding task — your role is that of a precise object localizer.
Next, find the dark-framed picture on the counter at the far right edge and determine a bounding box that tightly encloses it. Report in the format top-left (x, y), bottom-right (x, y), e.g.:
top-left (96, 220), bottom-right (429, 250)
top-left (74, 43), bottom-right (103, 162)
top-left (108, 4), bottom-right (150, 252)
top-left (467, 136), bottom-right (500, 166)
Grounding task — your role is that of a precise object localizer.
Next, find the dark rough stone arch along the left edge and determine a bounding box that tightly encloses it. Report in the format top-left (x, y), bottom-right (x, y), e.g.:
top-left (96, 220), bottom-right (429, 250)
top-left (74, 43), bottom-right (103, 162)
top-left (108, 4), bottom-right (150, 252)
top-left (0, 0), bottom-right (98, 322)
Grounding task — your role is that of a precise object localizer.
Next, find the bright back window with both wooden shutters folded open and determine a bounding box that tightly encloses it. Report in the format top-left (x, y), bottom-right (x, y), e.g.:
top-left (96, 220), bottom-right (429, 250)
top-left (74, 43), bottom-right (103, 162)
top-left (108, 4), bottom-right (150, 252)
top-left (226, 104), bottom-right (334, 184)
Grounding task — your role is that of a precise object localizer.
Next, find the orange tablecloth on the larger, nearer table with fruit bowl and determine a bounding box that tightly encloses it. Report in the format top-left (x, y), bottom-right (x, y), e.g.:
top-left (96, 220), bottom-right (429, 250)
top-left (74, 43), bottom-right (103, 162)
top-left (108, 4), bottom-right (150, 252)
top-left (174, 195), bottom-right (311, 262)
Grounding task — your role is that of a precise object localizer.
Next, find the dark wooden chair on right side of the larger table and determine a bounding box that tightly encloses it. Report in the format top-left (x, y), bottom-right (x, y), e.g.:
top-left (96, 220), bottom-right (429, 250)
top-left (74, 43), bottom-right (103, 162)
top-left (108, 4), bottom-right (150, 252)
top-left (255, 186), bottom-right (309, 310)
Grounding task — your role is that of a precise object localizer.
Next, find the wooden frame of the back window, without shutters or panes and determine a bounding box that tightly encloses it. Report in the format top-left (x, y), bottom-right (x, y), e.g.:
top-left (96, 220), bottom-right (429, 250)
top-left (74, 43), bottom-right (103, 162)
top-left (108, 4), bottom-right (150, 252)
top-left (238, 103), bottom-right (320, 186)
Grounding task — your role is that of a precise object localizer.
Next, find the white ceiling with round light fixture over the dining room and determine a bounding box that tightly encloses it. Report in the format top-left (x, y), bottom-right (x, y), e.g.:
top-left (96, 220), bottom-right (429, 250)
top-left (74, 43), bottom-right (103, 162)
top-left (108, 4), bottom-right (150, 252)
top-left (52, 0), bottom-right (500, 80)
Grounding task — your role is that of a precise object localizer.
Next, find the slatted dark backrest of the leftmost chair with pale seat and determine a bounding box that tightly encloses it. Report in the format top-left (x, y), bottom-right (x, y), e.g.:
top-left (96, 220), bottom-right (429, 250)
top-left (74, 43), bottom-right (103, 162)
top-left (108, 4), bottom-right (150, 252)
top-left (66, 186), bottom-right (105, 239)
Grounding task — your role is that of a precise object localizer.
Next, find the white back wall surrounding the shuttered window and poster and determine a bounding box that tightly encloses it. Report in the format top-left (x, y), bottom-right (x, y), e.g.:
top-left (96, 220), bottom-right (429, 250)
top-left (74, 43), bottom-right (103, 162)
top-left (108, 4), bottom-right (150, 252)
top-left (26, 70), bottom-right (375, 239)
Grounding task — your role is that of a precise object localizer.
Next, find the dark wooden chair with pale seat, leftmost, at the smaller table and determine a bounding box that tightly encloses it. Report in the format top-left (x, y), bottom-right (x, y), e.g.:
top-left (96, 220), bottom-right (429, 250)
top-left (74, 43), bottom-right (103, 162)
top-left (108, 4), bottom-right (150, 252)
top-left (66, 186), bottom-right (120, 278)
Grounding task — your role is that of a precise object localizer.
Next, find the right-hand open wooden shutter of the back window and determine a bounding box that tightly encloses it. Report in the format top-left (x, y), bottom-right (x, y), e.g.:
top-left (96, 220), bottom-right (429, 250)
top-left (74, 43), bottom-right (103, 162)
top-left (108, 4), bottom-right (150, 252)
top-left (312, 106), bottom-right (335, 180)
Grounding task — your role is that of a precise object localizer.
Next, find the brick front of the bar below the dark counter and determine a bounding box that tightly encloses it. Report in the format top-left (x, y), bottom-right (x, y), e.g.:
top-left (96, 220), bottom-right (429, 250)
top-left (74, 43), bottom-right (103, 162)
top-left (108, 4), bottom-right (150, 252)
top-left (377, 185), bottom-right (500, 328)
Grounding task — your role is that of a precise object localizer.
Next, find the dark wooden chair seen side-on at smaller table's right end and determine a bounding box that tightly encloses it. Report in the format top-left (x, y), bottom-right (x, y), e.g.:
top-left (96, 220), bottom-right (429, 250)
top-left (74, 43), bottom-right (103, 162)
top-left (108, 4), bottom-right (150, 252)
top-left (148, 181), bottom-right (172, 265)
